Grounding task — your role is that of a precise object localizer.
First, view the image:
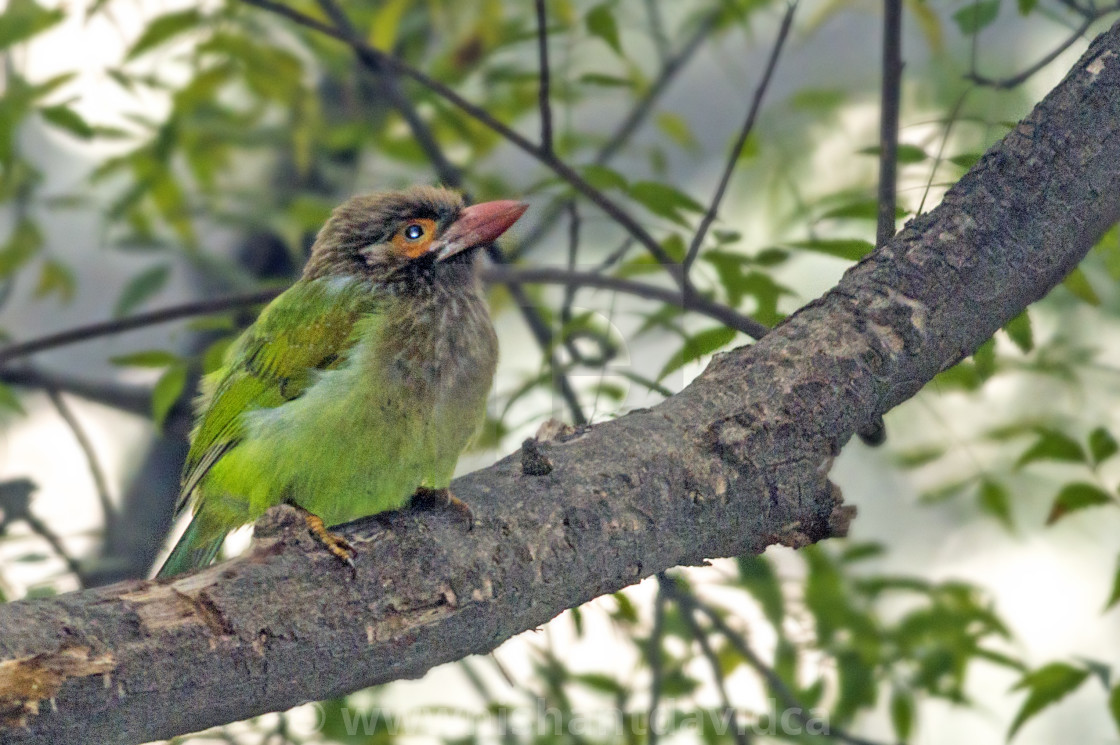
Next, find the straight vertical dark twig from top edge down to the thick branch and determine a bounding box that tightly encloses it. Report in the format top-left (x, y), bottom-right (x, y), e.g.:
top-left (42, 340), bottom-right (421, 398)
top-left (875, 0), bottom-right (903, 248)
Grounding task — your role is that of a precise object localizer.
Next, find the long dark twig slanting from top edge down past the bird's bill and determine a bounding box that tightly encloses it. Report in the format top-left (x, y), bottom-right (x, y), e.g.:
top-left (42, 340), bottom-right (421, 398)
top-left (243, 0), bottom-right (681, 275)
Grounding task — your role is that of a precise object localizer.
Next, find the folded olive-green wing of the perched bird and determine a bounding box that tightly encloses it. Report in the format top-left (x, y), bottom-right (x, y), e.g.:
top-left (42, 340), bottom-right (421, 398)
top-left (177, 279), bottom-right (374, 511)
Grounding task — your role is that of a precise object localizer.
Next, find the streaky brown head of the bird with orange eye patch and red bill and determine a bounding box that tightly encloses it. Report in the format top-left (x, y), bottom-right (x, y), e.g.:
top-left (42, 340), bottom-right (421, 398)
top-left (304, 186), bottom-right (528, 282)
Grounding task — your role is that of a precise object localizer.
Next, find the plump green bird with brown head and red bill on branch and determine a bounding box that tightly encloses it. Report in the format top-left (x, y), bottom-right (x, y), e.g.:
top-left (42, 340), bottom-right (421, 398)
top-left (156, 186), bottom-right (528, 578)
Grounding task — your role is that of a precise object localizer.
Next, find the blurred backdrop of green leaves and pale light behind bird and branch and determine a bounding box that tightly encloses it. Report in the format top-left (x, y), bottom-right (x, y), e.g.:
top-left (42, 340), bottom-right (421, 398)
top-left (0, 0), bottom-right (1120, 743)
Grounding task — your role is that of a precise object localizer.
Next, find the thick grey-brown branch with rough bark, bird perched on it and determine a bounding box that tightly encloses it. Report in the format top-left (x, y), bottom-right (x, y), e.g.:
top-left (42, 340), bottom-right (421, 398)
top-left (0, 25), bottom-right (1120, 744)
